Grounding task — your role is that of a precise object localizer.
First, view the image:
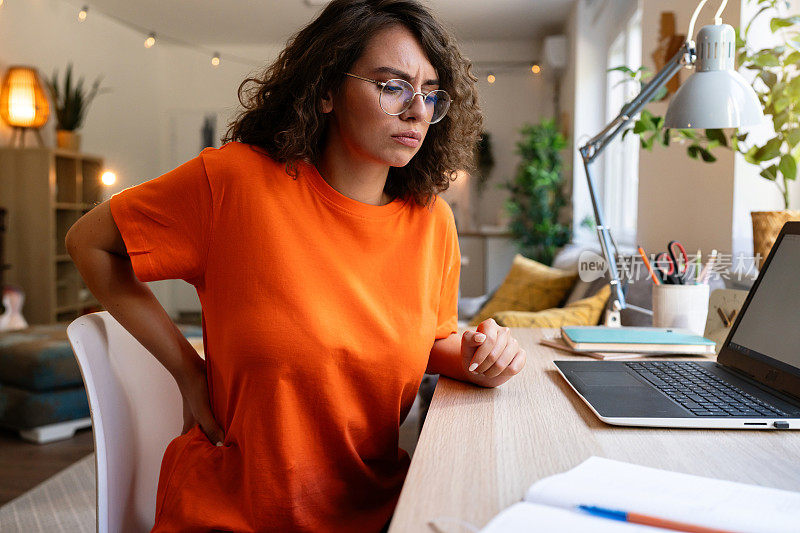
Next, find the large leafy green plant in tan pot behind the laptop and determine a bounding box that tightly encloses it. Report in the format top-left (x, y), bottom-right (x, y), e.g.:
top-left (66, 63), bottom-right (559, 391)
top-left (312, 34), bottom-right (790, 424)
top-left (615, 0), bottom-right (800, 267)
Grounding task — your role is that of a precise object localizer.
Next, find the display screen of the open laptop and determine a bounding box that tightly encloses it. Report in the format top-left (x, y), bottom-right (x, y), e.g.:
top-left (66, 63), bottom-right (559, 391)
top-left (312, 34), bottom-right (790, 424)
top-left (728, 233), bottom-right (800, 375)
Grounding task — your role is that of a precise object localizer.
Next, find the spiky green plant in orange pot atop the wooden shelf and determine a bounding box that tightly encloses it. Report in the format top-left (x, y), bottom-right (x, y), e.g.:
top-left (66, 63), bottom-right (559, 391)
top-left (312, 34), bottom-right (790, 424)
top-left (46, 63), bottom-right (108, 151)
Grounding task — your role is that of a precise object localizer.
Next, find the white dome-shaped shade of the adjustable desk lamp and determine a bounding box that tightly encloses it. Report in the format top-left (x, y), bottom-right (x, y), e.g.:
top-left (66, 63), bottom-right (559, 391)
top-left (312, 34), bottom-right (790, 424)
top-left (664, 24), bottom-right (764, 129)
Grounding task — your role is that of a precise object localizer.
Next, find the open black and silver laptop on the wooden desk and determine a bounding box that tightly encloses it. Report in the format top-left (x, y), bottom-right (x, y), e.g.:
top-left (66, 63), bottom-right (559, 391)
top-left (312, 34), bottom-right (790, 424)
top-left (555, 222), bottom-right (800, 429)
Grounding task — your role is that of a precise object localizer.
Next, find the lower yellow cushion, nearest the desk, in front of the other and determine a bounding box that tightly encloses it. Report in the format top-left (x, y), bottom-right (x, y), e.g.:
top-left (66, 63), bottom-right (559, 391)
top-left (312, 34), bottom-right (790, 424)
top-left (493, 285), bottom-right (611, 328)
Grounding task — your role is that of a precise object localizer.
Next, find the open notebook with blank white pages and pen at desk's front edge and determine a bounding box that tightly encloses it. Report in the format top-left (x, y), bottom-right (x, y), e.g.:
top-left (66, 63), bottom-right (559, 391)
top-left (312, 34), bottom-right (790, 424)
top-left (481, 457), bottom-right (800, 533)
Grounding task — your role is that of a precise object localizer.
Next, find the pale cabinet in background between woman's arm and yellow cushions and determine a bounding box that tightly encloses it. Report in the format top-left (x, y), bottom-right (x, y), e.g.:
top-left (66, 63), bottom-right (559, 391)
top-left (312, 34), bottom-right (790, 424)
top-left (458, 229), bottom-right (517, 298)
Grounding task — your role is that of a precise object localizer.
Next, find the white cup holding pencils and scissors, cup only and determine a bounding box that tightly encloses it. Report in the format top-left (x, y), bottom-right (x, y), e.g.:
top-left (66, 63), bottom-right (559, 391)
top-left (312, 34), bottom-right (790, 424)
top-left (653, 283), bottom-right (709, 335)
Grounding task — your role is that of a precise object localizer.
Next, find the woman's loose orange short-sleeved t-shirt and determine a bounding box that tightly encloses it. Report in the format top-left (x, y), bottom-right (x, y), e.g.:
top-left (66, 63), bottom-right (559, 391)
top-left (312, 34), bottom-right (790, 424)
top-left (110, 142), bottom-right (461, 532)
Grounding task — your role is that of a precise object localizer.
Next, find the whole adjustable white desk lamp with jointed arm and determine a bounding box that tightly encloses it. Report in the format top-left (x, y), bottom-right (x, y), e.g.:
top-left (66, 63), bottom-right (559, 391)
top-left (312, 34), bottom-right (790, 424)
top-left (579, 0), bottom-right (764, 326)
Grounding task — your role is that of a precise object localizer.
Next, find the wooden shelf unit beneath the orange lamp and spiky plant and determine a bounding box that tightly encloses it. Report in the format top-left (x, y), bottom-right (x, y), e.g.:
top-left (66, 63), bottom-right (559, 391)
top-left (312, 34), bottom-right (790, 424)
top-left (0, 147), bottom-right (104, 324)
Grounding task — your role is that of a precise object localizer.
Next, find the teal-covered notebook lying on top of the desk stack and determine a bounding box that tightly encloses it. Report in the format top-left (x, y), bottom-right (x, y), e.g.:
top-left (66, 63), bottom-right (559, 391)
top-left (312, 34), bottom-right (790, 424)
top-left (561, 326), bottom-right (715, 346)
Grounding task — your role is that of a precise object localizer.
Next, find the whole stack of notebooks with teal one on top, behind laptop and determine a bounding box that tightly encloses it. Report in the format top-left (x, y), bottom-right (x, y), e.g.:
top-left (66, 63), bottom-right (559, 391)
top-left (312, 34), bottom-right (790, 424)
top-left (541, 326), bottom-right (716, 359)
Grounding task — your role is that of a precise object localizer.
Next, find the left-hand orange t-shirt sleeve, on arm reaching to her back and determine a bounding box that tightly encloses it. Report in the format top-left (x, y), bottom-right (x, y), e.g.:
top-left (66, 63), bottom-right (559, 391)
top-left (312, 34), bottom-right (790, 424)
top-left (109, 155), bottom-right (213, 285)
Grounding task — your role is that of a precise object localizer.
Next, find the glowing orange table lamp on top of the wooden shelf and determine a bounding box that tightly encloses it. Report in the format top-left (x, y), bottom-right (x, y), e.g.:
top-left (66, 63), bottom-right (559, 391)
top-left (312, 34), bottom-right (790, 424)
top-left (0, 65), bottom-right (50, 147)
